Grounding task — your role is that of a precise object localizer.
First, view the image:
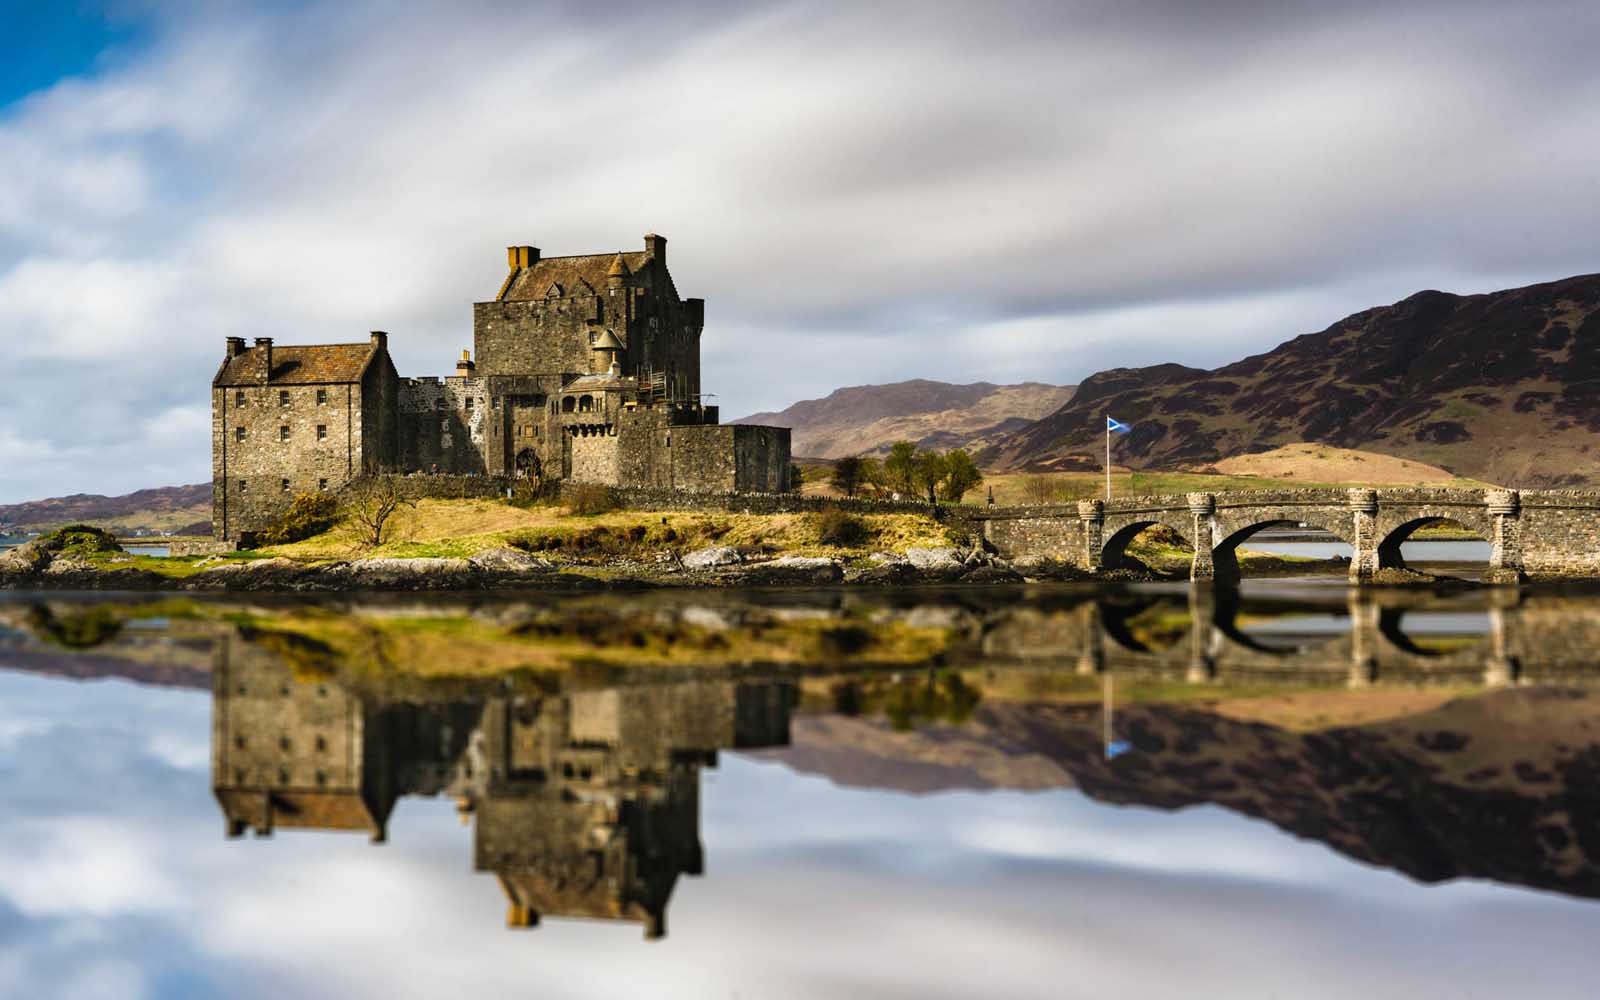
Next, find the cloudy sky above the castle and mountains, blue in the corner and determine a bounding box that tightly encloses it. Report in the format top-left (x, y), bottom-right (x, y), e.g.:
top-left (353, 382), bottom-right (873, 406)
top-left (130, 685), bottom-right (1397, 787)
top-left (0, 0), bottom-right (1600, 502)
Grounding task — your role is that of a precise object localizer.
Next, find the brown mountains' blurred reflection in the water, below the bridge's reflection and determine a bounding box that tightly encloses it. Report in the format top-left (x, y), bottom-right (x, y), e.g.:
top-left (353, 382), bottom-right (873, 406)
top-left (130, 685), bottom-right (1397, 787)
top-left (755, 688), bottom-right (1600, 898)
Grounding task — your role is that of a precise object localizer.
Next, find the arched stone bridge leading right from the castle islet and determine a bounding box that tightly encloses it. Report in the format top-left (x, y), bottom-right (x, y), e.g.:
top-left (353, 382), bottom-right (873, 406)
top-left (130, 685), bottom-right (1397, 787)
top-left (973, 488), bottom-right (1600, 582)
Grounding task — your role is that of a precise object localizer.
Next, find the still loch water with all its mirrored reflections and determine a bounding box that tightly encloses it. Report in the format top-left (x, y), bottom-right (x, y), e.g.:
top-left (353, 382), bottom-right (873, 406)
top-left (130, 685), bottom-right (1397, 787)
top-left (0, 579), bottom-right (1600, 998)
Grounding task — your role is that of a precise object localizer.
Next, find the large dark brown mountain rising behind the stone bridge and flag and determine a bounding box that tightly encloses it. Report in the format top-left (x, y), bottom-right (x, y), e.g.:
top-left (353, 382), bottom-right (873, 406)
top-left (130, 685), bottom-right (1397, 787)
top-left (978, 275), bottom-right (1600, 486)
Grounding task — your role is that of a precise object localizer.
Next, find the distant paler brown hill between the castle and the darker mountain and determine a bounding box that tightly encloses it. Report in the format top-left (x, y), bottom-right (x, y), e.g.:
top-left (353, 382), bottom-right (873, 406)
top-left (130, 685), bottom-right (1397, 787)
top-left (733, 379), bottom-right (1072, 458)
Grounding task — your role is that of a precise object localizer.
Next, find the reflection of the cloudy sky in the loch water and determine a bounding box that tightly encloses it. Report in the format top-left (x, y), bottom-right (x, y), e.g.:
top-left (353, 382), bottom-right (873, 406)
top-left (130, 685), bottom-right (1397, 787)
top-left (0, 650), bottom-right (1600, 1000)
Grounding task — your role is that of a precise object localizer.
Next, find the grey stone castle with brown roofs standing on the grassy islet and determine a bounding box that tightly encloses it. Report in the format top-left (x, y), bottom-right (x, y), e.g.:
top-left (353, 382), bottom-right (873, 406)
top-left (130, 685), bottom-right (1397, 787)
top-left (211, 234), bottom-right (790, 541)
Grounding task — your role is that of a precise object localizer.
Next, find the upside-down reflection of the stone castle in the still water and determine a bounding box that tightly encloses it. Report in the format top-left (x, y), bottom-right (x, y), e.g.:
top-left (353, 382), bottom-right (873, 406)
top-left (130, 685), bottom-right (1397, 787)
top-left (211, 630), bottom-right (795, 938)
